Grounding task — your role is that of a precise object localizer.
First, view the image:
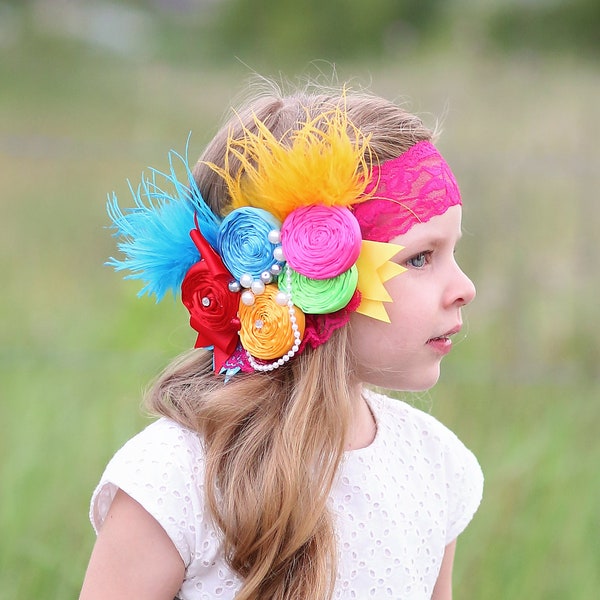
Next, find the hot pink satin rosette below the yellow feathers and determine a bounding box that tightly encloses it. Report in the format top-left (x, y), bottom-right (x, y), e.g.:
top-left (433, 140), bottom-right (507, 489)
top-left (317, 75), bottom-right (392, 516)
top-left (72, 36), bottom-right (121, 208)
top-left (281, 204), bottom-right (362, 279)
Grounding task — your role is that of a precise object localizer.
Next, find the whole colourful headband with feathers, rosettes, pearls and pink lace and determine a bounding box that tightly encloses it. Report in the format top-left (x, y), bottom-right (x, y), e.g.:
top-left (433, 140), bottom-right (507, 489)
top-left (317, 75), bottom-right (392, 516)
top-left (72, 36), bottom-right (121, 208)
top-left (108, 109), bottom-right (460, 378)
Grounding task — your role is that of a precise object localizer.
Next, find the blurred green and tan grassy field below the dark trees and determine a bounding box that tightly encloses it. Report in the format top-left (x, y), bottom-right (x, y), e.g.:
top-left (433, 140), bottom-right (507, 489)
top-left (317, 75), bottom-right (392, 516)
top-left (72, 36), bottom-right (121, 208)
top-left (0, 31), bottom-right (600, 600)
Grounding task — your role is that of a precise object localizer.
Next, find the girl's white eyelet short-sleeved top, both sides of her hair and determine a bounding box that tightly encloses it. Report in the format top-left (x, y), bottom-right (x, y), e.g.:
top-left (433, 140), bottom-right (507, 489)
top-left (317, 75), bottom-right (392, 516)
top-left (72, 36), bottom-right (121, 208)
top-left (90, 391), bottom-right (483, 600)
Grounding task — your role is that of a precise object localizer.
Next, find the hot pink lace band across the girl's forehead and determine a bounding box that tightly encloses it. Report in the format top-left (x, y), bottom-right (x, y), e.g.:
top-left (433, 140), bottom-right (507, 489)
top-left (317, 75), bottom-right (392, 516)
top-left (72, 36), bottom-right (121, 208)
top-left (354, 141), bottom-right (461, 242)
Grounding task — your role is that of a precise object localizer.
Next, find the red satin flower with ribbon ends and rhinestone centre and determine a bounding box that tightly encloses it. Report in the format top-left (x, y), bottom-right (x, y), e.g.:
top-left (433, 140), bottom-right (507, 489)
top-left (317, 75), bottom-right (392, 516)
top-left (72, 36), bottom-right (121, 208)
top-left (181, 229), bottom-right (240, 373)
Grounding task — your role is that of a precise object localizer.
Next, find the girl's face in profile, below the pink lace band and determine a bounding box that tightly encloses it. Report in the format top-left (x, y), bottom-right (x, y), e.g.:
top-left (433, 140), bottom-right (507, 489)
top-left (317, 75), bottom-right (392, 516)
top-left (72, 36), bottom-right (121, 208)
top-left (350, 205), bottom-right (475, 391)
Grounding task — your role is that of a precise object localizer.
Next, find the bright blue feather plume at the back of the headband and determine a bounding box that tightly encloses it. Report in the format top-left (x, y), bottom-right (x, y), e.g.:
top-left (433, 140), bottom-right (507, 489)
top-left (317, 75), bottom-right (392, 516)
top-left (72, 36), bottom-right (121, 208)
top-left (106, 144), bottom-right (221, 302)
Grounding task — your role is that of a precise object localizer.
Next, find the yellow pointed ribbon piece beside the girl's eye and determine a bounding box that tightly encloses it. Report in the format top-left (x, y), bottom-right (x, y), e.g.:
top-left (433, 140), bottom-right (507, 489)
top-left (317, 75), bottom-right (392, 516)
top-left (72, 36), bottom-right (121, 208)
top-left (356, 240), bottom-right (406, 323)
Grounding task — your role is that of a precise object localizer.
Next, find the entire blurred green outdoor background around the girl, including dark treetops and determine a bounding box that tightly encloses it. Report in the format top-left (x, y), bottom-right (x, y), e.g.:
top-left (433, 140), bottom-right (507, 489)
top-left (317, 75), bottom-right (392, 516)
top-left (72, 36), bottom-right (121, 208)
top-left (0, 0), bottom-right (600, 600)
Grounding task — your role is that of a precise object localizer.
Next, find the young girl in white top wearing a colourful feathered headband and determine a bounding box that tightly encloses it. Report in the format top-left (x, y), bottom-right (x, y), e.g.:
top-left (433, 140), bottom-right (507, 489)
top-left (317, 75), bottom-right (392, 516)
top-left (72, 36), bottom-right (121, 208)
top-left (81, 83), bottom-right (483, 600)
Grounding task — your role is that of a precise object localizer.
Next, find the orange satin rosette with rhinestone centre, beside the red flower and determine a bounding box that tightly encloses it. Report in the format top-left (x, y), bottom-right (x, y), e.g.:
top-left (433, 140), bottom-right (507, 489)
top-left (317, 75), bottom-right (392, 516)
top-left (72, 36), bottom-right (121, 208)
top-left (238, 284), bottom-right (305, 360)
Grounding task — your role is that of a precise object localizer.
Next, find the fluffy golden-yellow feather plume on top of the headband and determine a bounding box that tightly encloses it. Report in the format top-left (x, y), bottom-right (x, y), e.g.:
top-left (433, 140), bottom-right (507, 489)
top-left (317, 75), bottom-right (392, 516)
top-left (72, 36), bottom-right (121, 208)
top-left (209, 108), bottom-right (370, 221)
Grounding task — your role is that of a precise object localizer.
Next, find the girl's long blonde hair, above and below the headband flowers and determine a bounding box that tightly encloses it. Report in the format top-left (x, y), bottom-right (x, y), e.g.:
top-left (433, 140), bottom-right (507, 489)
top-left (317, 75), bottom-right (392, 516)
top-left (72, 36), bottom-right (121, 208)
top-left (147, 82), bottom-right (432, 600)
